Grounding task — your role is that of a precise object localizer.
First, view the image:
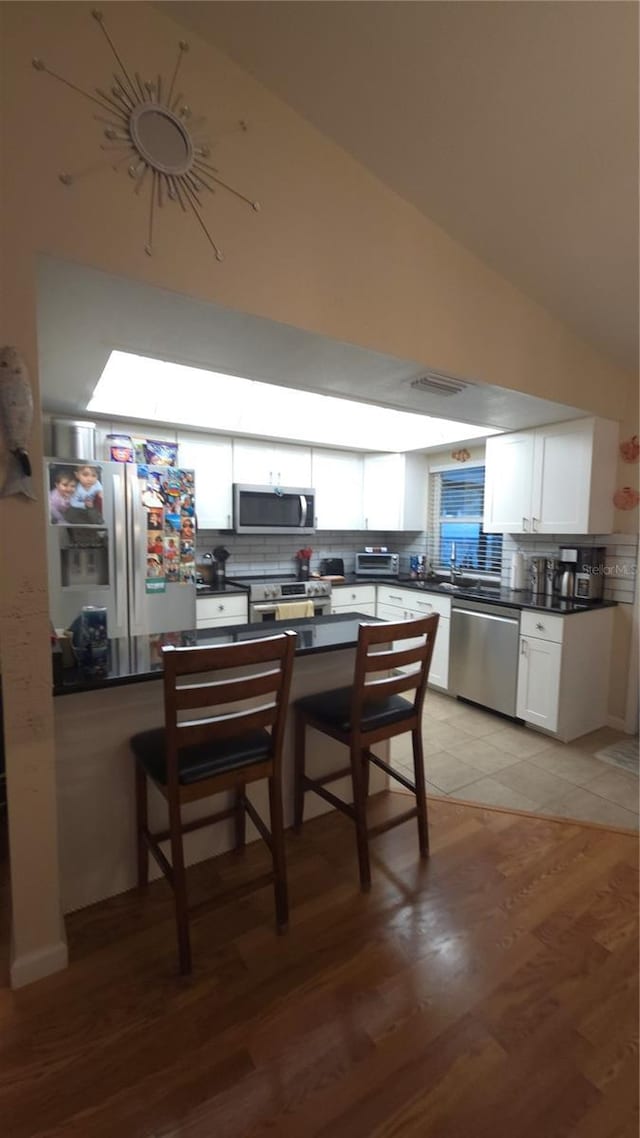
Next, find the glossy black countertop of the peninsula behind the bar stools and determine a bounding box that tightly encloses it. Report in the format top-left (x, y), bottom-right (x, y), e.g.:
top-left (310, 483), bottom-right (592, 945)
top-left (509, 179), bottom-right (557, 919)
top-left (54, 609), bottom-right (376, 695)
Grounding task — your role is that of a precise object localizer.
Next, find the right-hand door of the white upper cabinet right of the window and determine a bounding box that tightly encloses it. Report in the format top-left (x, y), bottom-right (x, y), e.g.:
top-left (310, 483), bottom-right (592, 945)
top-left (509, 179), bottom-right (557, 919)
top-left (532, 419), bottom-right (592, 534)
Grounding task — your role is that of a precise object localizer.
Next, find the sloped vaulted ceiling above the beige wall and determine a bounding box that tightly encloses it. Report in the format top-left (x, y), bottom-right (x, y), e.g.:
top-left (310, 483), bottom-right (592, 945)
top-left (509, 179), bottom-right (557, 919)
top-left (165, 0), bottom-right (638, 370)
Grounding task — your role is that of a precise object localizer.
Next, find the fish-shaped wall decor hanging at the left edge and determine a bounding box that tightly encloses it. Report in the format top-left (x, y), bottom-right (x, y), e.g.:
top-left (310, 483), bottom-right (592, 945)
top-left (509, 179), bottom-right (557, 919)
top-left (0, 345), bottom-right (35, 500)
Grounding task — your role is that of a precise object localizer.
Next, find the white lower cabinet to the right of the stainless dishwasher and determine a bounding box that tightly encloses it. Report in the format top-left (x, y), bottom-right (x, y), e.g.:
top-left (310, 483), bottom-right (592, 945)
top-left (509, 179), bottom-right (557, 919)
top-left (516, 608), bottom-right (614, 743)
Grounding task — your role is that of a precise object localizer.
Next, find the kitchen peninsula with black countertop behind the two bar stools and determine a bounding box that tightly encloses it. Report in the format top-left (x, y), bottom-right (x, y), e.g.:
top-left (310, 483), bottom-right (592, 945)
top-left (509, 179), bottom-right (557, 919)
top-left (54, 612), bottom-right (388, 913)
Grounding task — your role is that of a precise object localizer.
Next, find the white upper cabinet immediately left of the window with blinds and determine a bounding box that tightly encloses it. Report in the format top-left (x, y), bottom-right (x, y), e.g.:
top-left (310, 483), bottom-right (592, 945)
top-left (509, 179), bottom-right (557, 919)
top-left (363, 454), bottom-right (427, 530)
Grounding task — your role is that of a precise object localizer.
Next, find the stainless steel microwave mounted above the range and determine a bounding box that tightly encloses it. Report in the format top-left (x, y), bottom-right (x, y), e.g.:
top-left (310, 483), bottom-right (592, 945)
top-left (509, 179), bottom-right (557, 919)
top-left (233, 483), bottom-right (315, 535)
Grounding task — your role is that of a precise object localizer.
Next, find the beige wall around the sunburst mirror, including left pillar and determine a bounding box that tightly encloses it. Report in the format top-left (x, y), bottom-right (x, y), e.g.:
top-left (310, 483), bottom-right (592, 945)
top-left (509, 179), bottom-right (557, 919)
top-left (0, 3), bottom-right (637, 983)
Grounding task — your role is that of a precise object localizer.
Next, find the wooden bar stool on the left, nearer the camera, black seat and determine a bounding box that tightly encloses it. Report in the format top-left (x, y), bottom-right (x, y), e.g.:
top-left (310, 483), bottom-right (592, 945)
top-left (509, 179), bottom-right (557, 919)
top-left (130, 630), bottom-right (296, 973)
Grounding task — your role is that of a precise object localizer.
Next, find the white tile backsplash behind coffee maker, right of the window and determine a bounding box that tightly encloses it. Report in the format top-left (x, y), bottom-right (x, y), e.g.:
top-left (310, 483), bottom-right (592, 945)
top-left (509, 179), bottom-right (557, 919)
top-left (501, 534), bottom-right (638, 604)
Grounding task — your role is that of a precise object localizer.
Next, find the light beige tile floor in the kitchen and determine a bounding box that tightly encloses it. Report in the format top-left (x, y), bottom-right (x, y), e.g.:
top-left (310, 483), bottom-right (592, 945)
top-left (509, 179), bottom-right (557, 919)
top-left (393, 691), bottom-right (640, 830)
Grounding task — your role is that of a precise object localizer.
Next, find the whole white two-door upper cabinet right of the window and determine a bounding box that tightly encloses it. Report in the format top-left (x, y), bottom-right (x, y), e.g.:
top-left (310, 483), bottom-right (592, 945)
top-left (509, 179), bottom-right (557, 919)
top-left (484, 419), bottom-right (618, 534)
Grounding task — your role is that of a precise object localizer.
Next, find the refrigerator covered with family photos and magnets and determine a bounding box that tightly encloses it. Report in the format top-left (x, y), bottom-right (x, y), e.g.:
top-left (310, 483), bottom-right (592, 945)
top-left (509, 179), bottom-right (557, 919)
top-left (44, 457), bottom-right (196, 640)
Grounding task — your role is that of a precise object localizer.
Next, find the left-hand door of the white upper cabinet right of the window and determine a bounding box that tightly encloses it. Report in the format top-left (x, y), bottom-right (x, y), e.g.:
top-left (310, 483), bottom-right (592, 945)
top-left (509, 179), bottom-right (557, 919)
top-left (483, 431), bottom-right (534, 534)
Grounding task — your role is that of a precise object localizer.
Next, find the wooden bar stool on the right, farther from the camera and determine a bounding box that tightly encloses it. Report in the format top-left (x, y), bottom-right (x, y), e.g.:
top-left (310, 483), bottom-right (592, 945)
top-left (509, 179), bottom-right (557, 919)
top-left (294, 615), bottom-right (440, 891)
